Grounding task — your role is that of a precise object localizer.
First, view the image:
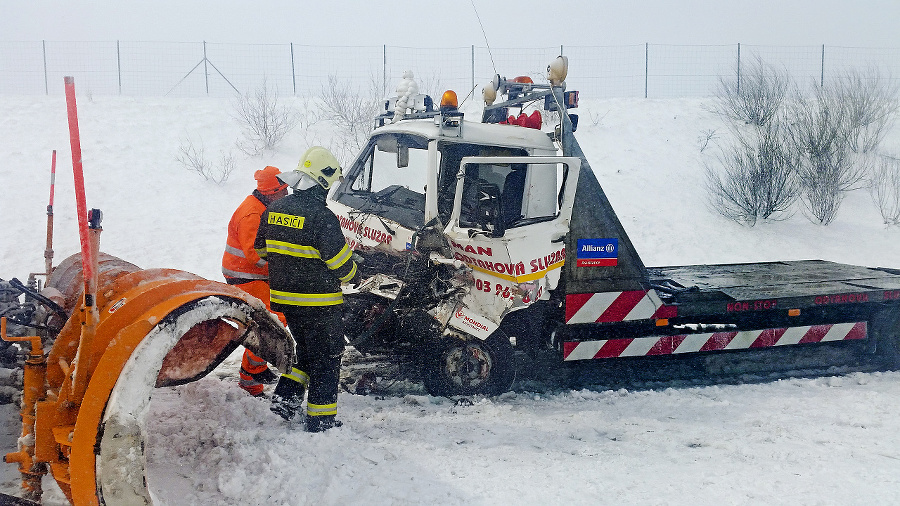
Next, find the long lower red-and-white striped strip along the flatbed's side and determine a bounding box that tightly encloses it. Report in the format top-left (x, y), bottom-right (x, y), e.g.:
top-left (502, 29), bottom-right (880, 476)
top-left (563, 322), bottom-right (868, 360)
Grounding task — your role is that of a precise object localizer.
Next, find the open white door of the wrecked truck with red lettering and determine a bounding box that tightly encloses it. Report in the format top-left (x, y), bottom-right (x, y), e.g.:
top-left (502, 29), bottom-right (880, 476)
top-left (444, 156), bottom-right (581, 338)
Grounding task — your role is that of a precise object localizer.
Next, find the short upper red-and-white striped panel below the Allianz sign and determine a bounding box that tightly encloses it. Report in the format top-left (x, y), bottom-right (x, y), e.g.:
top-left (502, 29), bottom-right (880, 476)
top-left (566, 290), bottom-right (676, 324)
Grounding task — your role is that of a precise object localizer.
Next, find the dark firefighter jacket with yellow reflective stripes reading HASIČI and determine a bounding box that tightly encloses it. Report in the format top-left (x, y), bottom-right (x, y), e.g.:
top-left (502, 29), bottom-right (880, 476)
top-left (253, 187), bottom-right (356, 311)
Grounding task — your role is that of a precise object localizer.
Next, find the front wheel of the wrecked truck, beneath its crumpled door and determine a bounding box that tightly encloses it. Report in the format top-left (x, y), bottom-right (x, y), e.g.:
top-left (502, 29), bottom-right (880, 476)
top-left (423, 330), bottom-right (516, 397)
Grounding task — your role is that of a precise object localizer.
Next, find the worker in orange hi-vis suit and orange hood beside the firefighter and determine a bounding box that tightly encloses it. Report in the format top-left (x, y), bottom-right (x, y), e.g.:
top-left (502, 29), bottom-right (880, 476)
top-left (222, 166), bottom-right (287, 397)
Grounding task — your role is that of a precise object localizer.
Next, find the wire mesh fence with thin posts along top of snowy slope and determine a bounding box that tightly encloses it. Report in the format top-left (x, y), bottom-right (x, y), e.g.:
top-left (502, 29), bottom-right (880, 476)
top-left (0, 41), bottom-right (900, 98)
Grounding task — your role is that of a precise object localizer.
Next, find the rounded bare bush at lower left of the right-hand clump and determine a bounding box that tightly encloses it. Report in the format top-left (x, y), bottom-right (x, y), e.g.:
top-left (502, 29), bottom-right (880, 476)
top-left (706, 121), bottom-right (799, 227)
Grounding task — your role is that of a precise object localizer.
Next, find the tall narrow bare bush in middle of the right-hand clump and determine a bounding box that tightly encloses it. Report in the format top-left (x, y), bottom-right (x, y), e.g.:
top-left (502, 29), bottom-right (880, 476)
top-left (789, 84), bottom-right (866, 225)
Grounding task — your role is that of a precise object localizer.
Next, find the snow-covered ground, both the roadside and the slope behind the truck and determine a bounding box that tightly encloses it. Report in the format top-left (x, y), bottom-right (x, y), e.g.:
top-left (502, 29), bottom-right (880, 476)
top-left (0, 92), bottom-right (900, 505)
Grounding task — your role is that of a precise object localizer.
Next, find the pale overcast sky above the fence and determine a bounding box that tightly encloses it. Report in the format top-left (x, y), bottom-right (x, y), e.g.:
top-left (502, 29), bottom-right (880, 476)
top-left (0, 0), bottom-right (900, 47)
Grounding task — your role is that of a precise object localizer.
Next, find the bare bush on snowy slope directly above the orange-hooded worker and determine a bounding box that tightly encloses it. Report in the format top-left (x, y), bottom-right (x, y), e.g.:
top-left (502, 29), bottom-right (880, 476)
top-left (234, 79), bottom-right (299, 156)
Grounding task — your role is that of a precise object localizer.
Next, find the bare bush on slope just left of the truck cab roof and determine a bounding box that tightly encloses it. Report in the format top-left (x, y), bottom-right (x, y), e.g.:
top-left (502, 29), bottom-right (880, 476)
top-left (321, 75), bottom-right (384, 162)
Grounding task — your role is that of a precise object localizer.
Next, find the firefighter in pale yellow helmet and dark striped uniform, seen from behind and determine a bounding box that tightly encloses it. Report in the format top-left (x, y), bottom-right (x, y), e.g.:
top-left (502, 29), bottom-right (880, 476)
top-left (254, 146), bottom-right (357, 432)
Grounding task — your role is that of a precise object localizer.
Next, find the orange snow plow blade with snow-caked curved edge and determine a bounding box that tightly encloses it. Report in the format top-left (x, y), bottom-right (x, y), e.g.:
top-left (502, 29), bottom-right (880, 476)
top-left (6, 254), bottom-right (294, 505)
